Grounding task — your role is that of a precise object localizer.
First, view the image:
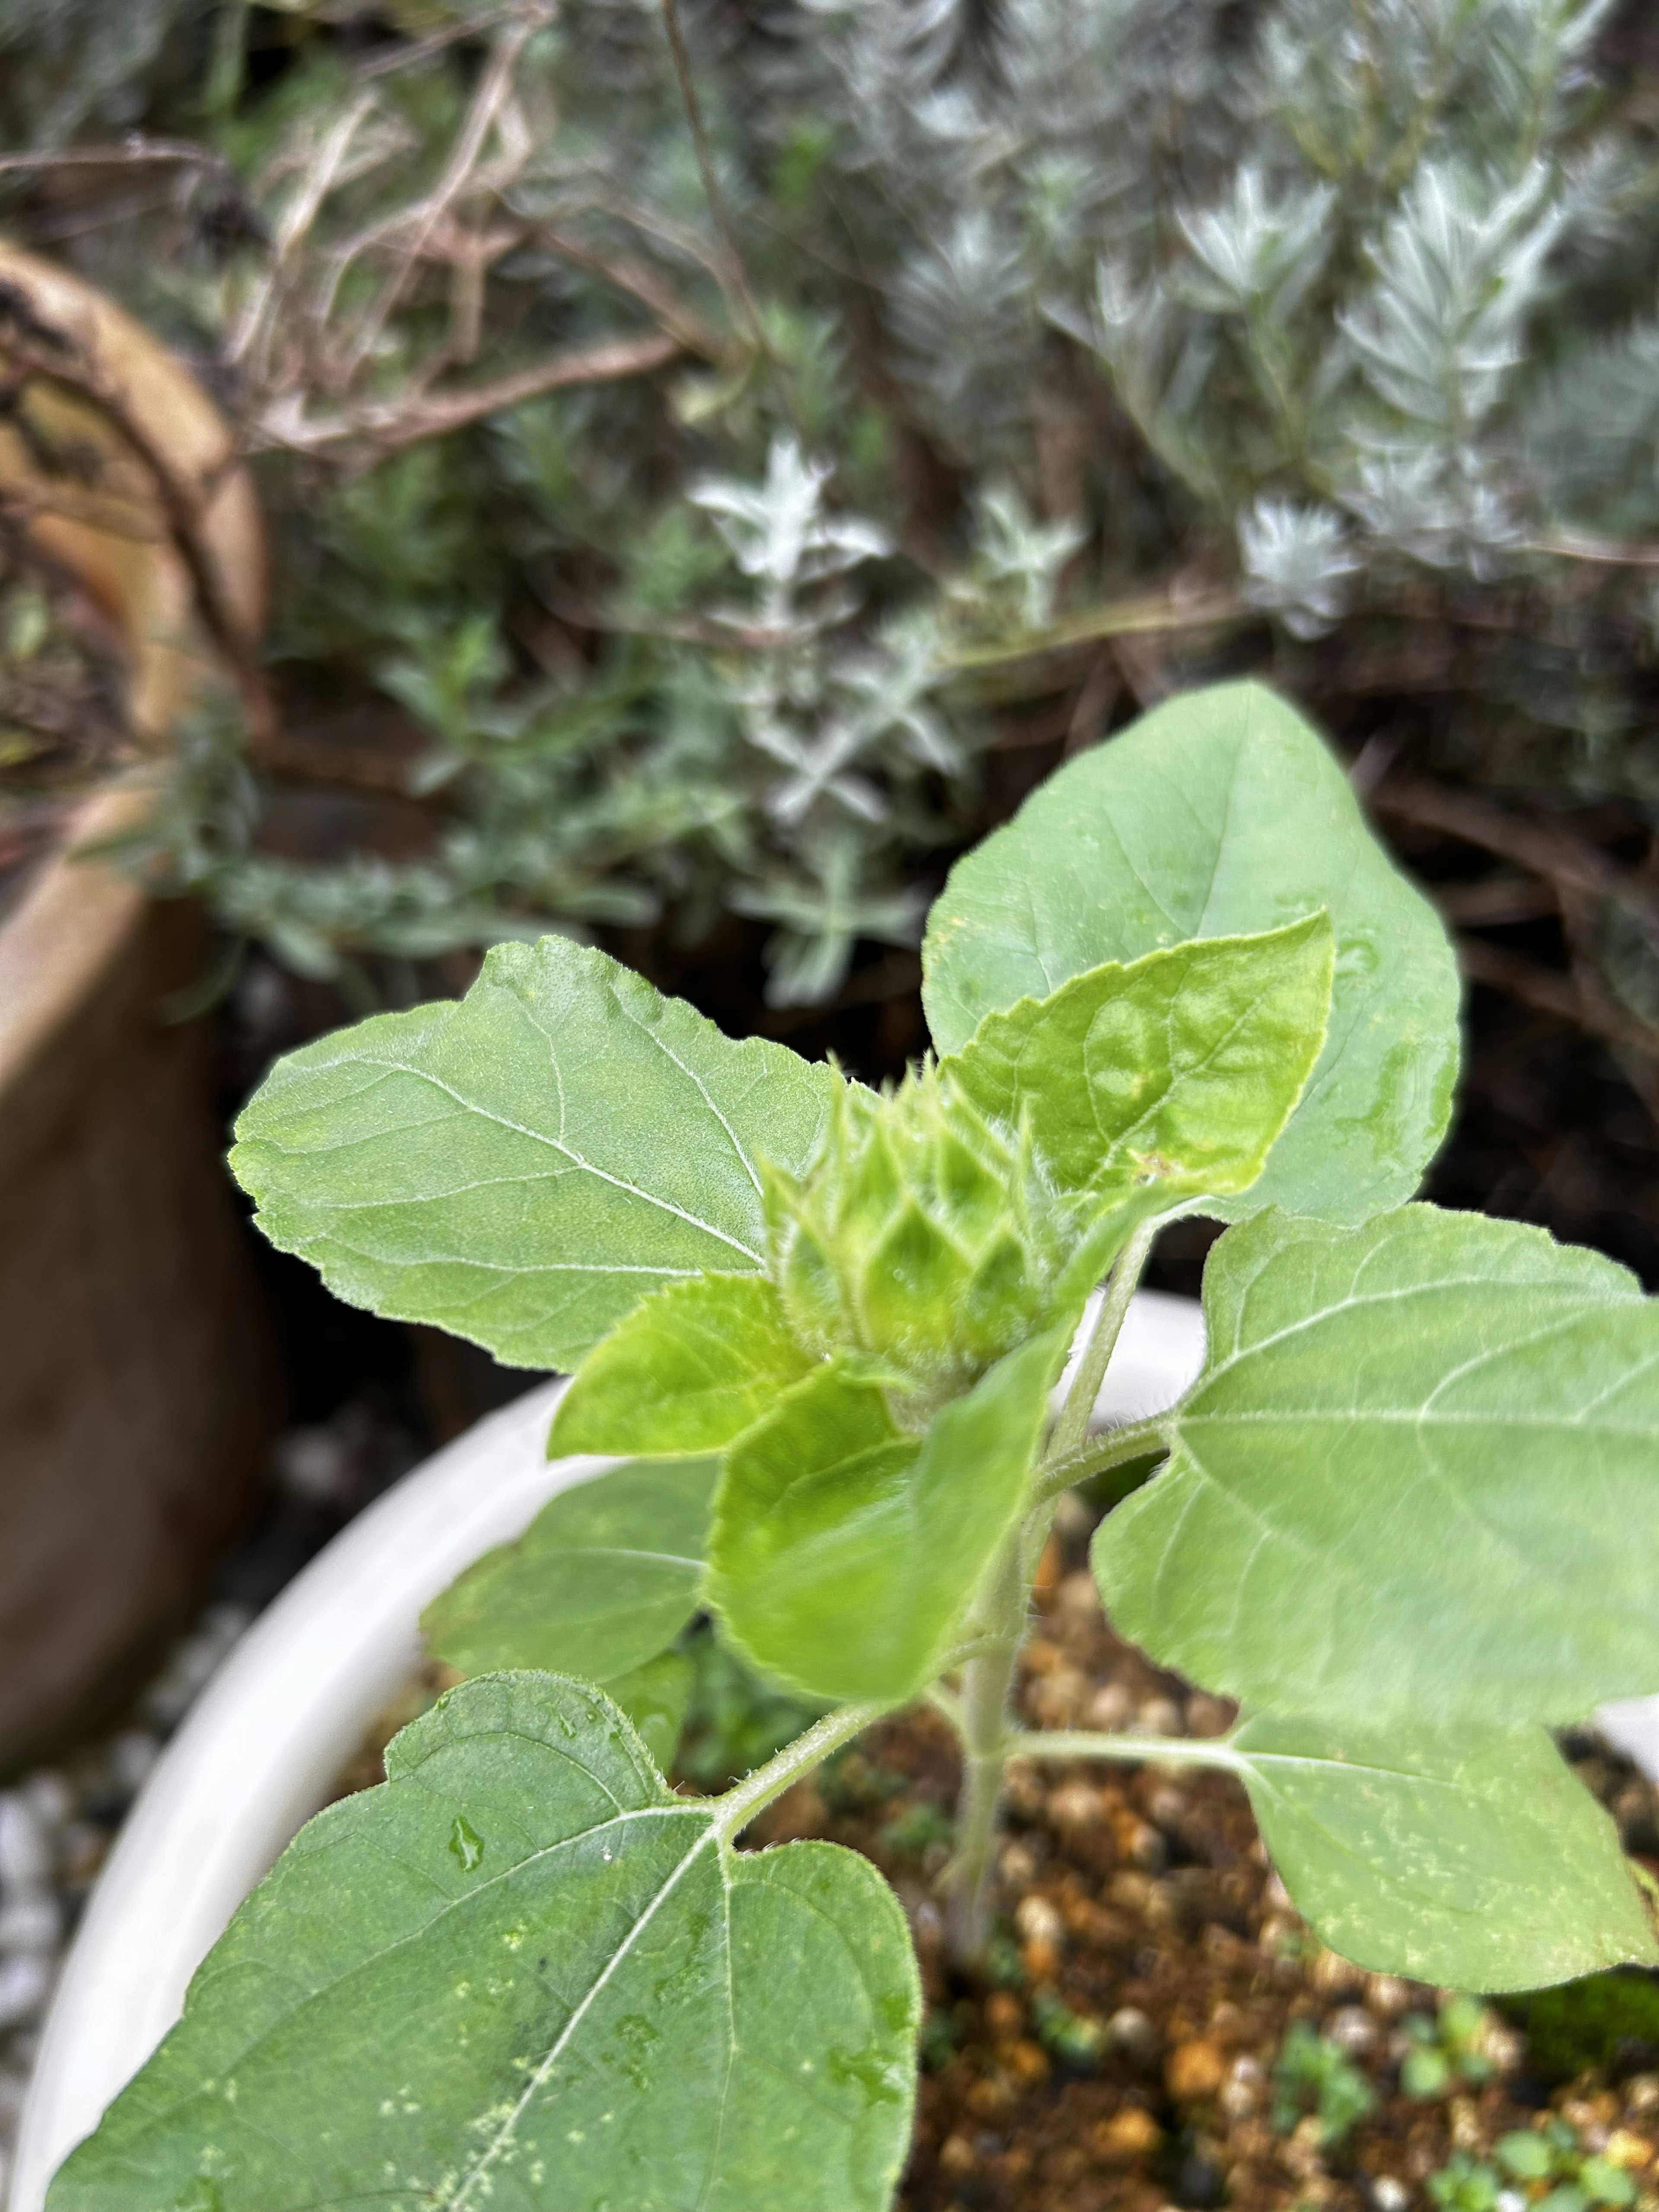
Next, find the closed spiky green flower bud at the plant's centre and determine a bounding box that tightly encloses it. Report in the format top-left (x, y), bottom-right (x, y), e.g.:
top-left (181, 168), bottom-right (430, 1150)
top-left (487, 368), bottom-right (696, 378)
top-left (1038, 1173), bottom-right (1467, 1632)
top-left (766, 1064), bottom-right (1064, 1418)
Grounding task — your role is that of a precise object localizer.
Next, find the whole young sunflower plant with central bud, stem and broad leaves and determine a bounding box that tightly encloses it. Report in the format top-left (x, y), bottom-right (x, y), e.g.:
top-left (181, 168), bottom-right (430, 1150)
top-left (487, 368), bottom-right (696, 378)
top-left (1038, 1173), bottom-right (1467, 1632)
top-left (51, 686), bottom-right (1659, 2212)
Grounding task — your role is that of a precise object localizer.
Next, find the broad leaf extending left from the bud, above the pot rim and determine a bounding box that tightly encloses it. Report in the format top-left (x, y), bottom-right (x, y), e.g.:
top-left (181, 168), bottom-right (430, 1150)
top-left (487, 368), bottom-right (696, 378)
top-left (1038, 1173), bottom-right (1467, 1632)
top-left (230, 938), bottom-right (838, 1367)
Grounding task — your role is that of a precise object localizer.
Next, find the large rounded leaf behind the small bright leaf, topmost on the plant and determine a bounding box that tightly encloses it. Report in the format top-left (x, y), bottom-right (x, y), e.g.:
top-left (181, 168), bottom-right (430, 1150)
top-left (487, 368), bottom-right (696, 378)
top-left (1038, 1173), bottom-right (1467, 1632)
top-left (922, 683), bottom-right (1458, 1221)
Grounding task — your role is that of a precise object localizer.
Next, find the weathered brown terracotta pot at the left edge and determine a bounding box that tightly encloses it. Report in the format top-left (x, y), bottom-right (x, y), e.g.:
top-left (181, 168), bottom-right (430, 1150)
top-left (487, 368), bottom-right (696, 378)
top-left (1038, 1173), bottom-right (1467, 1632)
top-left (0, 245), bottom-right (279, 1765)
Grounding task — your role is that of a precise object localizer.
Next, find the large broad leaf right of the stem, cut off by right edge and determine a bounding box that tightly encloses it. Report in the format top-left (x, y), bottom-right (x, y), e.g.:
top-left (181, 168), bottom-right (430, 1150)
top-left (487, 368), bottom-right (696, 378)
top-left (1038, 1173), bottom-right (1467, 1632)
top-left (1095, 1205), bottom-right (1659, 1723)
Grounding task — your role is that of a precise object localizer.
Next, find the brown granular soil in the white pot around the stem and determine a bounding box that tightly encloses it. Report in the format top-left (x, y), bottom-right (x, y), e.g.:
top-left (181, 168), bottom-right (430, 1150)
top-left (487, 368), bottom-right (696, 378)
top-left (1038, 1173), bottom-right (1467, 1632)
top-left (748, 1555), bottom-right (1659, 2212)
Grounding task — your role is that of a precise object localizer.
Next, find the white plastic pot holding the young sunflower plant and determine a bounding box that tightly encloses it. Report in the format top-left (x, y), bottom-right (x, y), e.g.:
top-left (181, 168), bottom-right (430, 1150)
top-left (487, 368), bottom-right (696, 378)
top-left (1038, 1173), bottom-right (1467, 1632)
top-left (11, 1292), bottom-right (1203, 2212)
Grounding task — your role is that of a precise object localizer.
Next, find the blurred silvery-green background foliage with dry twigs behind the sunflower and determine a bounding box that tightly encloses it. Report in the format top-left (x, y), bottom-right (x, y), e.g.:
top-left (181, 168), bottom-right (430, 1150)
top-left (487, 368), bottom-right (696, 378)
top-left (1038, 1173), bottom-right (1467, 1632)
top-left (0, 0), bottom-right (1659, 1272)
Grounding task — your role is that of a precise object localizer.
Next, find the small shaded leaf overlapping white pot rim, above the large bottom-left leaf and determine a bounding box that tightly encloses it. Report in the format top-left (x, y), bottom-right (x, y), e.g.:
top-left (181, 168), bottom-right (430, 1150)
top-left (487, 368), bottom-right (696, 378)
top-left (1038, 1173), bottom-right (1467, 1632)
top-left (420, 1458), bottom-right (719, 1683)
